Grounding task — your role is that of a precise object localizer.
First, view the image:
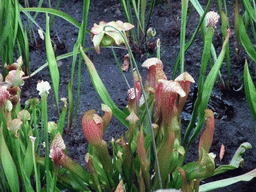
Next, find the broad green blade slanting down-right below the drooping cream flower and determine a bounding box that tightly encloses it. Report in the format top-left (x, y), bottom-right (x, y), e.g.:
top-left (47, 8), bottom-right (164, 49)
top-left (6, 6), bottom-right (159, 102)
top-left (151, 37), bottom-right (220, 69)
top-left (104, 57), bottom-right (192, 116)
top-left (80, 46), bottom-right (129, 127)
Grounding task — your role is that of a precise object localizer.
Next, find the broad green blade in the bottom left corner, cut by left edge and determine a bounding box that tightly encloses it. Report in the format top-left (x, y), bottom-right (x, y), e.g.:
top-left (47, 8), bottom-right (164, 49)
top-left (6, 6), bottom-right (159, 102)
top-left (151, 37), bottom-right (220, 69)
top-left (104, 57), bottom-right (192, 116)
top-left (0, 125), bottom-right (20, 192)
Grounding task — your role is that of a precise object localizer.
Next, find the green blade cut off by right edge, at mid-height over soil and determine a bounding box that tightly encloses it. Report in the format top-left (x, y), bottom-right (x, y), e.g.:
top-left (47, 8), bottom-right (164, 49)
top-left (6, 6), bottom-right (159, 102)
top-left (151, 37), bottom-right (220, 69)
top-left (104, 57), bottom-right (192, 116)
top-left (244, 61), bottom-right (256, 121)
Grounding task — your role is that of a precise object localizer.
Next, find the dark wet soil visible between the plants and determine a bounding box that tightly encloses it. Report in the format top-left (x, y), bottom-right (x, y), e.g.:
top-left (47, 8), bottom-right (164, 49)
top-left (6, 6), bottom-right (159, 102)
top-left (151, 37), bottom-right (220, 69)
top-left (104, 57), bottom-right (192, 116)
top-left (19, 0), bottom-right (256, 192)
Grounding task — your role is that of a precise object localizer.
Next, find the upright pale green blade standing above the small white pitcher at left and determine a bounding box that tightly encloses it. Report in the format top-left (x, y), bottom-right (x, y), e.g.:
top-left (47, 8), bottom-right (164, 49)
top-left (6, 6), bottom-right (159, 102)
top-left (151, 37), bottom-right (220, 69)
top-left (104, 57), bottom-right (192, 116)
top-left (45, 13), bottom-right (60, 111)
